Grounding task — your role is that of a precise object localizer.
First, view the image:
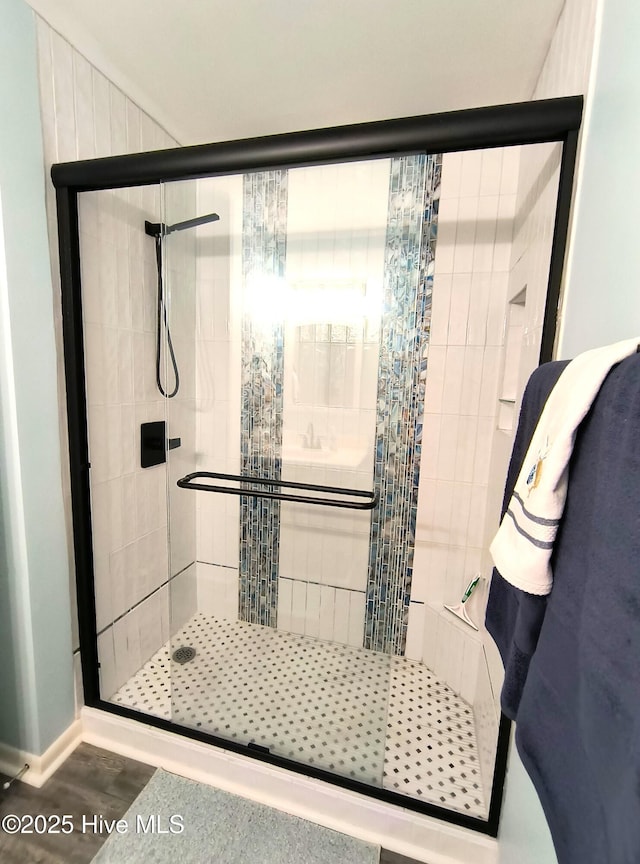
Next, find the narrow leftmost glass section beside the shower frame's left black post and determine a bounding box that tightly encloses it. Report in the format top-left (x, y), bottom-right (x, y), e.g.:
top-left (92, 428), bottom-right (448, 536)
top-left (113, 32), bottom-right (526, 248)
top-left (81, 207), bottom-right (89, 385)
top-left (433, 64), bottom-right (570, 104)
top-left (78, 186), bottom-right (171, 717)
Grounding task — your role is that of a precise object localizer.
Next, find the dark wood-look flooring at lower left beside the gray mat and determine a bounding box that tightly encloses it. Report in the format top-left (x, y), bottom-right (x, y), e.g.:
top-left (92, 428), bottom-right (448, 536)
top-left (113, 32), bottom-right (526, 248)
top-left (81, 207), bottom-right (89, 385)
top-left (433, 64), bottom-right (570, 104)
top-left (0, 744), bottom-right (428, 864)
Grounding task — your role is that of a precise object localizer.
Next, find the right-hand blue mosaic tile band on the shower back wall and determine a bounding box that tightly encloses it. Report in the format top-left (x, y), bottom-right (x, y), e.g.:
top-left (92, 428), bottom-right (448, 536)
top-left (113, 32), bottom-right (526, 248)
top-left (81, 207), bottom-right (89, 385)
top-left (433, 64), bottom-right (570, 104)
top-left (364, 155), bottom-right (442, 654)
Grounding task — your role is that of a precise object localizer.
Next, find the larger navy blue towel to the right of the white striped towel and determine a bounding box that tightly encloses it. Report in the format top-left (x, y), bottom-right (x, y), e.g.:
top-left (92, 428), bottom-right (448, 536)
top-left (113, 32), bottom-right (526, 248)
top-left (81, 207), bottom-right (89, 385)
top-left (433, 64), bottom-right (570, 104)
top-left (487, 354), bottom-right (640, 864)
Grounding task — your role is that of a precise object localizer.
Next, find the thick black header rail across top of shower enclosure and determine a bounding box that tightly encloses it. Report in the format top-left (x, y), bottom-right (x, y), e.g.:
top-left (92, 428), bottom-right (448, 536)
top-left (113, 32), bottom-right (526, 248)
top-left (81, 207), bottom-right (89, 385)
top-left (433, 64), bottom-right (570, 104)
top-left (51, 96), bottom-right (582, 192)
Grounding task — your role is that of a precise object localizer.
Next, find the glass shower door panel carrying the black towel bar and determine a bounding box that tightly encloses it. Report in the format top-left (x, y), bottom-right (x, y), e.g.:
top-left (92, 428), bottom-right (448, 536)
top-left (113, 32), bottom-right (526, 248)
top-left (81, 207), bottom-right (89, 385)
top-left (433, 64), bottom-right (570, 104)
top-left (164, 160), bottom-right (398, 787)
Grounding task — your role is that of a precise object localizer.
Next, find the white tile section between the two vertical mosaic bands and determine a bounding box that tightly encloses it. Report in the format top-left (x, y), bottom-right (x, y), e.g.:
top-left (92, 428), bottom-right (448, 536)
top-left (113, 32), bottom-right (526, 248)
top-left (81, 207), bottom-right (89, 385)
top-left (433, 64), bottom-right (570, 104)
top-left (278, 160), bottom-right (390, 645)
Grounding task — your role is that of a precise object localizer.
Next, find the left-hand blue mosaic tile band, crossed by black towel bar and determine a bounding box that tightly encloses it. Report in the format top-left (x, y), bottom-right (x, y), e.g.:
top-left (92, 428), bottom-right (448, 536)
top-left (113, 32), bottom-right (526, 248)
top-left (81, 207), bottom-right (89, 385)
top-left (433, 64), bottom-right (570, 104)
top-left (239, 171), bottom-right (287, 627)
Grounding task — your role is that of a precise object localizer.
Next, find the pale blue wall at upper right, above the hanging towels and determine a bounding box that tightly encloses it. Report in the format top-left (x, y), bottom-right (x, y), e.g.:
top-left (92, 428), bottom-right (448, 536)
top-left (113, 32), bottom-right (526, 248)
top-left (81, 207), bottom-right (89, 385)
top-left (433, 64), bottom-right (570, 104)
top-left (559, 0), bottom-right (640, 358)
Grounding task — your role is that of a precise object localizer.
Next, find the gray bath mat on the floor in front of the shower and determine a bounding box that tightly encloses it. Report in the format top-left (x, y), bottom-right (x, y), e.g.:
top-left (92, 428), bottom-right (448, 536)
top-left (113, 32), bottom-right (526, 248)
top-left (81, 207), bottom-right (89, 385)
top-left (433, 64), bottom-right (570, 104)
top-left (93, 770), bottom-right (380, 864)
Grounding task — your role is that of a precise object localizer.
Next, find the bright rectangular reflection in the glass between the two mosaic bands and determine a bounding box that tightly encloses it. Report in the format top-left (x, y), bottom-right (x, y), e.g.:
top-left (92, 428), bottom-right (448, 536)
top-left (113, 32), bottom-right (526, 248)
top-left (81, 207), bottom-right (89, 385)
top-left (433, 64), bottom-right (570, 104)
top-left (288, 279), bottom-right (381, 408)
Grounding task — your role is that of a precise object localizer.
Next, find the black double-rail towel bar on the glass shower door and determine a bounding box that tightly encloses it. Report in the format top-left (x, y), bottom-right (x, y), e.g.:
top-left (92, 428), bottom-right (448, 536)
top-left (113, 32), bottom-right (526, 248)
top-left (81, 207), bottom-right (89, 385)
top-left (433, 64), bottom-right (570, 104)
top-left (177, 471), bottom-right (378, 510)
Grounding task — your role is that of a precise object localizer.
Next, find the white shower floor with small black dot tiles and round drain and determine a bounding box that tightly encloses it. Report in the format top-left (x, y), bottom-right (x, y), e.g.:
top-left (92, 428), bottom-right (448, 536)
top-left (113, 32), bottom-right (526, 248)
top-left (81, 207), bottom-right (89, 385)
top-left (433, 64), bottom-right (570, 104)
top-left (112, 614), bottom-right (486, 818)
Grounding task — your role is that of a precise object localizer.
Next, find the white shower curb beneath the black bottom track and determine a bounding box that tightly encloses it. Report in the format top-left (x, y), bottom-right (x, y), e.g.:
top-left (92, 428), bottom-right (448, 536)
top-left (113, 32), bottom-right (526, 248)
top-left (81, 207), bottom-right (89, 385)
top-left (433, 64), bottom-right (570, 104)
top-left (81, 708), bottom-right (498, 864)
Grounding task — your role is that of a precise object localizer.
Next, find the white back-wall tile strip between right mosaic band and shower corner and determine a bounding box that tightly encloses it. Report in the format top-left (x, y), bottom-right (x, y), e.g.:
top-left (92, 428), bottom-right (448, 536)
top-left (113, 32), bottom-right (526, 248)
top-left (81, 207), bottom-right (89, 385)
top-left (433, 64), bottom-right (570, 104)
top-left (410, 148), bottom-right (520, 632)
